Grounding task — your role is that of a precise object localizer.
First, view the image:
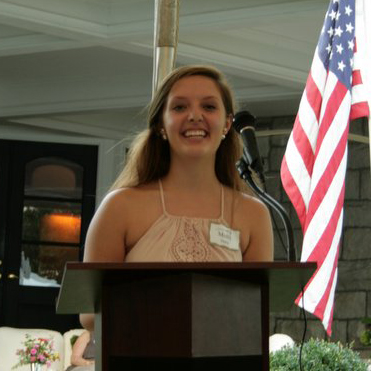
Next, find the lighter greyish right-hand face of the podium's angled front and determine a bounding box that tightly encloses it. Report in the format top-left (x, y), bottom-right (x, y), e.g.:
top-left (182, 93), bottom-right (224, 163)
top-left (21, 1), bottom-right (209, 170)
top-left (192, 275), bottom-right (262, 357)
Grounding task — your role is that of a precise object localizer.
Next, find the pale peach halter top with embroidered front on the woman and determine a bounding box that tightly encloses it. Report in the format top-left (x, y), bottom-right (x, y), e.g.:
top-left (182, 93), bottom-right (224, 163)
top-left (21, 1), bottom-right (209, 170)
top-left (125, 181), bottom-right (242, 262)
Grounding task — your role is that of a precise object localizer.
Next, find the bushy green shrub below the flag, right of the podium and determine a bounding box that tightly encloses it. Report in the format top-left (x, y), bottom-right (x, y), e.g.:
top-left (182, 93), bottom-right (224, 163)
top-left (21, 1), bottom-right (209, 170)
top-left (270, 339), bottom-right (367, 371)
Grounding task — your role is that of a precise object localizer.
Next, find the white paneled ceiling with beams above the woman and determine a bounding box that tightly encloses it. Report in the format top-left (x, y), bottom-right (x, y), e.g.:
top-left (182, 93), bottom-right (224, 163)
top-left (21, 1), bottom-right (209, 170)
top-left (0, 0), bottom-right (328, 139)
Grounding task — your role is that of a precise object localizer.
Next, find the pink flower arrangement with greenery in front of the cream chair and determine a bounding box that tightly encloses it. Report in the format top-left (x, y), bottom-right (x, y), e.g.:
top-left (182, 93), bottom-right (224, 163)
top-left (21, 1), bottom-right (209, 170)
top-left (12, 334), bottom-right (59, 369)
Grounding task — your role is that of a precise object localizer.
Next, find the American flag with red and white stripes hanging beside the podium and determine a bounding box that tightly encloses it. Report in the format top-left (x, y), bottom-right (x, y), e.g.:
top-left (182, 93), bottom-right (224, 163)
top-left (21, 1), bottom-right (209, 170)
top-left (281, 0), bottom-right (369, 335)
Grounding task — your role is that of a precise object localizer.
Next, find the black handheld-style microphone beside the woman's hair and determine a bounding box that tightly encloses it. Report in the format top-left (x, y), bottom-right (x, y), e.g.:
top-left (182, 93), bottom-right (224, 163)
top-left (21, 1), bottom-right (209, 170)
top-left (233, 111), bottom-right (264, 183)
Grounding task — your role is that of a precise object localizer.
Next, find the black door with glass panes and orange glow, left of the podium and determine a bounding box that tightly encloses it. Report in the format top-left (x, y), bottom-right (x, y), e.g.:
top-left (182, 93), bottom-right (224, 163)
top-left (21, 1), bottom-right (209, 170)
top-left (0, 140), bottom-right (98, 332)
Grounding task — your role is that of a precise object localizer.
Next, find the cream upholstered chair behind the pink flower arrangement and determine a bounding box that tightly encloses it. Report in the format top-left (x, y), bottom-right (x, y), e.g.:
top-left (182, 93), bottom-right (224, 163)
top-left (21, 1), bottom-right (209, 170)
top-left (0, 327), bottom-right (64, 371)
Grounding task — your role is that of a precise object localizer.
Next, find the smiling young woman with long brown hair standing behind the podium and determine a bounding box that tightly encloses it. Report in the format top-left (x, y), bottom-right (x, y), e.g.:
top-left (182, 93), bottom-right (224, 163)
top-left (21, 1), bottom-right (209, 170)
top-left (80, 66), bottom-right (273, 330)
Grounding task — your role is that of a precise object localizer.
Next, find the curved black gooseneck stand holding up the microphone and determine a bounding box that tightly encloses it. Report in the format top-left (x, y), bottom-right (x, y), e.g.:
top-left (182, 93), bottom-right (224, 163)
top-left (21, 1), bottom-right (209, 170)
top-left (236, 156), bottom-right (297, 262)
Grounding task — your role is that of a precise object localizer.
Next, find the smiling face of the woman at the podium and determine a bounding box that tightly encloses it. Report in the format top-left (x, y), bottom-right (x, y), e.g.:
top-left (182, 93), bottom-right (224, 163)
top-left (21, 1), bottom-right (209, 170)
top-left (163, 75), bottom-right (231, 158)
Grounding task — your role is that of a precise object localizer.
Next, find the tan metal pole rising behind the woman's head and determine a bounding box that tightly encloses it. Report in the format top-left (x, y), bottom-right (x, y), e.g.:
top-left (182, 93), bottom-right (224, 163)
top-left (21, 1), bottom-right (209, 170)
top-left (152, 0), bottom-right (179, 96)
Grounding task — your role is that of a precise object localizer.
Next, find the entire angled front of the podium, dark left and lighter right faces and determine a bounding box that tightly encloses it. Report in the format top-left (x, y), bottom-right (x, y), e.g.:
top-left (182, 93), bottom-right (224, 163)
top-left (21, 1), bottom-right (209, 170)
top-left (102, 273), bottom-right (262, 358)
